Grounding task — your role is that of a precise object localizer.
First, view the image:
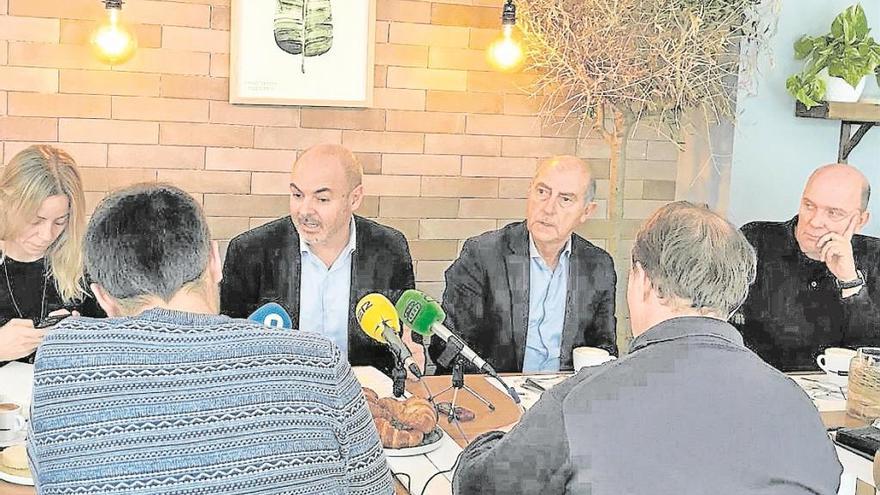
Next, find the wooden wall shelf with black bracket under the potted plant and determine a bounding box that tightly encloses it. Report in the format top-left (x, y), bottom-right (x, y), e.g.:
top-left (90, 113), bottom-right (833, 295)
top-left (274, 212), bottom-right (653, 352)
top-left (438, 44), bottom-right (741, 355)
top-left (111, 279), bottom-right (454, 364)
top-left (794, 101), bottom-right (880, 163)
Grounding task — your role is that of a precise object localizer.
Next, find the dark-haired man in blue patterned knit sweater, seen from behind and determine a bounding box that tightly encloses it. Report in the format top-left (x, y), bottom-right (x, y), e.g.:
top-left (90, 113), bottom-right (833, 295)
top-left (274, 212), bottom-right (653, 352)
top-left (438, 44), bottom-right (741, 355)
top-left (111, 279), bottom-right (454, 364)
top-left (28, 184), bottom-right (392, 495)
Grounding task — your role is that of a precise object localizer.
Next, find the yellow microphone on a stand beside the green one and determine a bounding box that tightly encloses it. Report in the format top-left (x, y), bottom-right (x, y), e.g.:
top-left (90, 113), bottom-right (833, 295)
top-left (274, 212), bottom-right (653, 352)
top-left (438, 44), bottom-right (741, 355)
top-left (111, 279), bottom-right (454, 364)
top-left (354, 293), bottom-right (422, 378)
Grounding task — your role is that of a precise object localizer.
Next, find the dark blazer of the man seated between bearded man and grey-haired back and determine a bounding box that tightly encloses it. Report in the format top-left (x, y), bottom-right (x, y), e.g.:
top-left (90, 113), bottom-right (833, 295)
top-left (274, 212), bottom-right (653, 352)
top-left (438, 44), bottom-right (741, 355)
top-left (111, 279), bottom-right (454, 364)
top-left (430, 222), bottom-right (617, 372)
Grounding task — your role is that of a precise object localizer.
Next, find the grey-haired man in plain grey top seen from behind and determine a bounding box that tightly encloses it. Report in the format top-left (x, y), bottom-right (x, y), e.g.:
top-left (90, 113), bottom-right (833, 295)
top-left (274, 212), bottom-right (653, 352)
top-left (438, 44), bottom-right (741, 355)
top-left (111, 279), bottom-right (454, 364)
top-left (453, 202), bottom-right (841, 495)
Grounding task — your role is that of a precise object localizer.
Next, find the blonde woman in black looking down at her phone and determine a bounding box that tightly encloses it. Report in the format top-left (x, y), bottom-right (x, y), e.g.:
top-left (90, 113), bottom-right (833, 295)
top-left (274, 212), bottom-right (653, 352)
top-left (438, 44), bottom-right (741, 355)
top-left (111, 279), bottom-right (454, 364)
top-left (0, 145), bottom-right (96, 364)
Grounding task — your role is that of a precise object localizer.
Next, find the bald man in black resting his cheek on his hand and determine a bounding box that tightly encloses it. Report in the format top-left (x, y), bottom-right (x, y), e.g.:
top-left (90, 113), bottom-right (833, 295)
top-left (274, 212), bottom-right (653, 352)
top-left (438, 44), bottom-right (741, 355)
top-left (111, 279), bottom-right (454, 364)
top-left (731, 164), bottom-right (880, 371)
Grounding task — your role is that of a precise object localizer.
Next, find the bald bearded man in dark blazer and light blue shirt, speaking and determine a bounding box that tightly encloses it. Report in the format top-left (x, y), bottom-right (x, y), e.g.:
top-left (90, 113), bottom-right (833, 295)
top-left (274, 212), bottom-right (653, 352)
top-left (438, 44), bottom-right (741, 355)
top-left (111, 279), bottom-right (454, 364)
top-left (220, 144), bottom-right (415, 373)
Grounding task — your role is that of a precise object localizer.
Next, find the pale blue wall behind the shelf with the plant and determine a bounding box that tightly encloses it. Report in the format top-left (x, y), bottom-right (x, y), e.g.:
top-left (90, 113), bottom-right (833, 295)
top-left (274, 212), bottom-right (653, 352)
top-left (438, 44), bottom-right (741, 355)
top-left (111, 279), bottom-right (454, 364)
top-left (728, 0), bottom-right (880, 236)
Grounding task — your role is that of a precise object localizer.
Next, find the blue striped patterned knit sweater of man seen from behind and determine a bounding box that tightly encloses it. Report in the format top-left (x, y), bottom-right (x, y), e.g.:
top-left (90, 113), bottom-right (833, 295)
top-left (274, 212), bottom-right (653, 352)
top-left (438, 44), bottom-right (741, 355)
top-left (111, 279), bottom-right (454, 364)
top-left (28, 309), bottom-right (392, 495)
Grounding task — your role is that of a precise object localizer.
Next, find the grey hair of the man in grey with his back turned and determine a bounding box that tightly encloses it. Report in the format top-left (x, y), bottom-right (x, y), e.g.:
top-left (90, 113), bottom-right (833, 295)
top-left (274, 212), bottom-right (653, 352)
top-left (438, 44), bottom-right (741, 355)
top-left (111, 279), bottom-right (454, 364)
top-left (632, 201), bottom-right (757, 318)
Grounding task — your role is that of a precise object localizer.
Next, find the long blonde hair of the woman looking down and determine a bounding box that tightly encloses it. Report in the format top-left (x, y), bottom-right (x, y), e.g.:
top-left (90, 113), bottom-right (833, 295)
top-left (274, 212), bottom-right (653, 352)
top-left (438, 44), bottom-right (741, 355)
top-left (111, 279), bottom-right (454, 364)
top-left (0, 145), bottom-right (85, 302)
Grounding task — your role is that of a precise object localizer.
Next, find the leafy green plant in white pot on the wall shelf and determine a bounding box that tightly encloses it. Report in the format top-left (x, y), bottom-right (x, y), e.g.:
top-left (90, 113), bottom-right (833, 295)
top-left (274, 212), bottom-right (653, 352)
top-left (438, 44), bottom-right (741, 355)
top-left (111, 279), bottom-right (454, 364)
top-left (785, 4), bottom-right (880, 108)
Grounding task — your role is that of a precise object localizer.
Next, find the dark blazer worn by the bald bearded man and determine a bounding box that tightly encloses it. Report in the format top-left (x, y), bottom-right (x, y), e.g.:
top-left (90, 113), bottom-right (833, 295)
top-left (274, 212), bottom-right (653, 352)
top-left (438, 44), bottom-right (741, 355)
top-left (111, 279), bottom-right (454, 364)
top-left (220, 215), bottom-right (415, 373)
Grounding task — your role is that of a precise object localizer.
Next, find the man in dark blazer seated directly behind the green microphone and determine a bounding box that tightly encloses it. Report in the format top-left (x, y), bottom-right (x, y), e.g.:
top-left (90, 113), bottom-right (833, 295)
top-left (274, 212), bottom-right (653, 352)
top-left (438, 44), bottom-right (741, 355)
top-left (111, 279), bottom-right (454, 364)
top-left (430, 156), bottom-right (617, 372)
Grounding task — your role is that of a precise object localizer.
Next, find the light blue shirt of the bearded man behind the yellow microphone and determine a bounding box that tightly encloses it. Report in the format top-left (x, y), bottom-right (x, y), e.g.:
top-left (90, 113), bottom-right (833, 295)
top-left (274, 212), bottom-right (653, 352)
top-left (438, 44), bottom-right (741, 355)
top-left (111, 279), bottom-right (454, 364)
top-left (299, 218), bottom-right (356, 359)
